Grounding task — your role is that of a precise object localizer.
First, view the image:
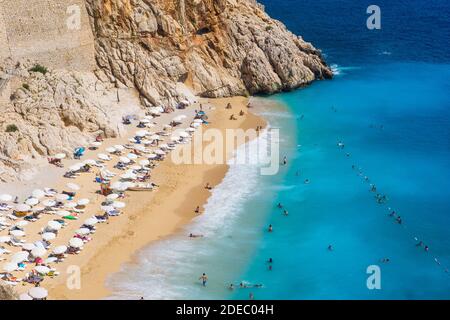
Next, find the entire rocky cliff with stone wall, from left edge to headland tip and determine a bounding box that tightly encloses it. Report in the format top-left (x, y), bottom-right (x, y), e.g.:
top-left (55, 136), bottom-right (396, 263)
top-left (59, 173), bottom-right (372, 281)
top-left (0, 0), bottom-right (332, 181)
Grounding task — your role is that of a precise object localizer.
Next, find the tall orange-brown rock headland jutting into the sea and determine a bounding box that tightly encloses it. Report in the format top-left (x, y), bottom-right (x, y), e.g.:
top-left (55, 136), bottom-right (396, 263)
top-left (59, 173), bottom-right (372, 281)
top-left (86, 0), bottom-right (332, 105)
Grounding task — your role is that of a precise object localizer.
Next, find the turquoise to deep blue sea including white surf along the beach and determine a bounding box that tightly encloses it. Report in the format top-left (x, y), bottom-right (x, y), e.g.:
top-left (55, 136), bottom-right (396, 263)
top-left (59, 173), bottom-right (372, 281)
top-left (110, 0), bottom-right (450, 299)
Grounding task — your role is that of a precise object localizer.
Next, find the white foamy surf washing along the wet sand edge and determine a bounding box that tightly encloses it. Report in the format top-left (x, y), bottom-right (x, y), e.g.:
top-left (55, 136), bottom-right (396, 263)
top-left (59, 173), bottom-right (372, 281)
top-left (108, 130), bottom-right (268, 299)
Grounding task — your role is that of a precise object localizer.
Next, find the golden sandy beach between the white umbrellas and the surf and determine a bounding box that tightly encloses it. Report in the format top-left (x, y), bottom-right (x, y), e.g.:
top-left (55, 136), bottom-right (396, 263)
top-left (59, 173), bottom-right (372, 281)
top-left (1, 97), bottom-right (265, 299)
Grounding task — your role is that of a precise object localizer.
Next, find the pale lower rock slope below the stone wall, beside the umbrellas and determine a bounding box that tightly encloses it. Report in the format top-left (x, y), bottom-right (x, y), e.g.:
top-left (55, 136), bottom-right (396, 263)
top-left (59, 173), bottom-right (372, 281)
top-left (0, 58), bottom-right (139, 181)
